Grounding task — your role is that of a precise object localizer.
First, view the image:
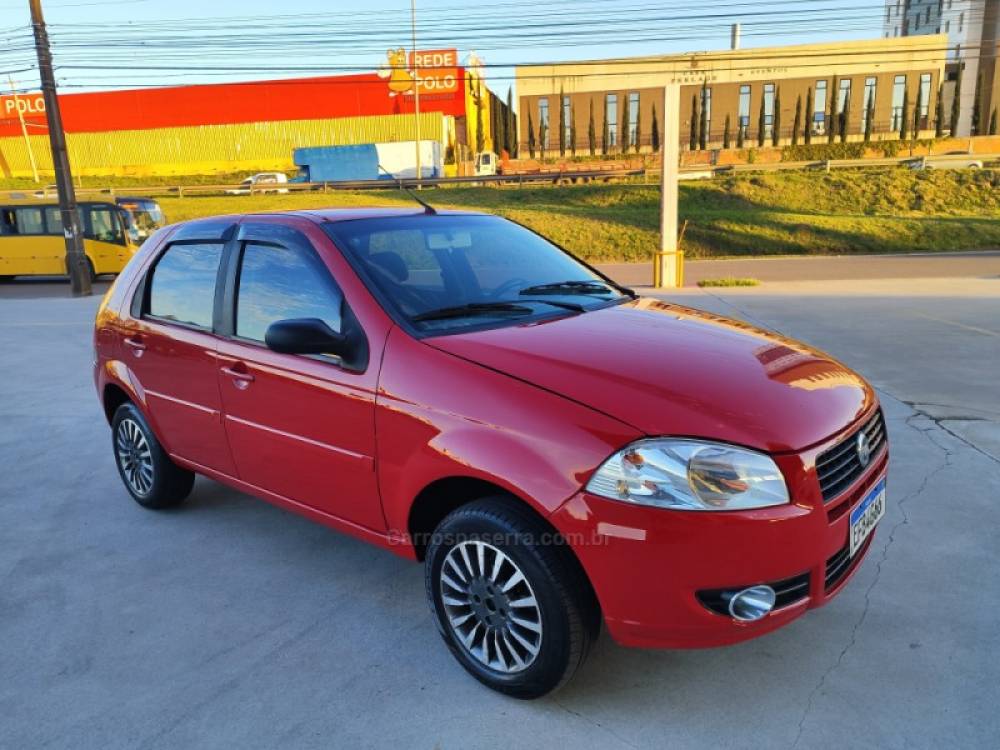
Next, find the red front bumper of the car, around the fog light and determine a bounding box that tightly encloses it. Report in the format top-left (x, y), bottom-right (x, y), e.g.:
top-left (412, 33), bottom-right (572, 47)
top-left (551, 424), bottom-right (888, 648)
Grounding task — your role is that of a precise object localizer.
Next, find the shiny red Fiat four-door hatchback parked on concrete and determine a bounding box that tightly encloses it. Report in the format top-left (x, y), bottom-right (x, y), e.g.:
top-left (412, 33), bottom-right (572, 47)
top-left (94, 209), bottom-right (888, 698)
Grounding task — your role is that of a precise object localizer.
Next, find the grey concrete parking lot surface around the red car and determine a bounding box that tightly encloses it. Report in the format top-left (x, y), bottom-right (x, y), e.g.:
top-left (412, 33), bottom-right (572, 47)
top-left (0, 279), bottom-right (1000, 749)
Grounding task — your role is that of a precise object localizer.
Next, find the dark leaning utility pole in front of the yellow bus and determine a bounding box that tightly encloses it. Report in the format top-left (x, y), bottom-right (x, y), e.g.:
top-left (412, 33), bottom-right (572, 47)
top-left (28, 0), bottom-right (91, 297)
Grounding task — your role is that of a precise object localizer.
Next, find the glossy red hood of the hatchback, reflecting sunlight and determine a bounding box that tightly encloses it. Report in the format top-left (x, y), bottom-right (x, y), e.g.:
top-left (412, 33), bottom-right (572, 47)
top-left (425, 299), bottom-right (875, 452)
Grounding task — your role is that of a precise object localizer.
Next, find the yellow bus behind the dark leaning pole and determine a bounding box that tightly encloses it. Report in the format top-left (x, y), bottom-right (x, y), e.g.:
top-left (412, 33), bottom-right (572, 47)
top-left (0, 201), bottom-right (145, 281)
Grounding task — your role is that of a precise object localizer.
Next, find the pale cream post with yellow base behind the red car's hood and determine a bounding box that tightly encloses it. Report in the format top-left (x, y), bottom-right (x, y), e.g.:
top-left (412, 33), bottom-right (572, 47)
top-left (653, 83), bottom-right (684, 288)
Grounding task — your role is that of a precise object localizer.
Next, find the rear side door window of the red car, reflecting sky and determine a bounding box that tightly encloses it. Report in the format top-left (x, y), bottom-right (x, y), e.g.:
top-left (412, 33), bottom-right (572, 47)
top-left (148, 243), bottom-right (223, 330)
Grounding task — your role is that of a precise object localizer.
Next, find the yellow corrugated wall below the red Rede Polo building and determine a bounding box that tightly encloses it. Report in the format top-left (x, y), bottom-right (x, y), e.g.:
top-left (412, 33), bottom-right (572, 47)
top-left (0, 107), bottom-right (446, 177)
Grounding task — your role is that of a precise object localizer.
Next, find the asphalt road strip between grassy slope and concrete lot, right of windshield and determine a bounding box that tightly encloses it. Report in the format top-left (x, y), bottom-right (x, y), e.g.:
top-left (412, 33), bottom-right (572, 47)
top-left (597, 250), bottom-right (1000, 286)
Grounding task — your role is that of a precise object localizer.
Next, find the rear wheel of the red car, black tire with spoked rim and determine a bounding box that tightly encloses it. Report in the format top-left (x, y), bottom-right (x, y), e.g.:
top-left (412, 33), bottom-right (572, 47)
top-left (111, 403), bottom-right (194, 510)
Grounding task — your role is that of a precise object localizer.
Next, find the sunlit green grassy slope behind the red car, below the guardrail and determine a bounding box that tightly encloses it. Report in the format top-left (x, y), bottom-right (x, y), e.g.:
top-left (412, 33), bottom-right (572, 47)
top-left (7, 168), bottom-right (1000, 261)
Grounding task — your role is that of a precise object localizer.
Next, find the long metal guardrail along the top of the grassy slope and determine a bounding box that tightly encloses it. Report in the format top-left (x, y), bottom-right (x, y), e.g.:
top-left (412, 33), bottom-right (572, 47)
top-left (0, 154), bottom-right (1000, 200)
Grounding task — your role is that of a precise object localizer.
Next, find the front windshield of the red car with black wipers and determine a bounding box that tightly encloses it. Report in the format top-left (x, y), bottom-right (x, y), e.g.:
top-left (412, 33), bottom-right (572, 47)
top-left (325, 215), bottom-right (627, 332)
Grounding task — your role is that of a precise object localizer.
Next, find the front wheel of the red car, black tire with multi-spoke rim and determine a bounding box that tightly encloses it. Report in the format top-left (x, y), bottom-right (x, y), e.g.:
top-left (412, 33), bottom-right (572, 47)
top-left (424, 496), bottom-right (600, 699)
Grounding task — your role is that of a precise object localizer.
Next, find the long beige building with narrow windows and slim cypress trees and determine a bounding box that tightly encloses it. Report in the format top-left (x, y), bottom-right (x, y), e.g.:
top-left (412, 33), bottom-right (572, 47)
top-left (516, 36), bottom-right (950, 155)
